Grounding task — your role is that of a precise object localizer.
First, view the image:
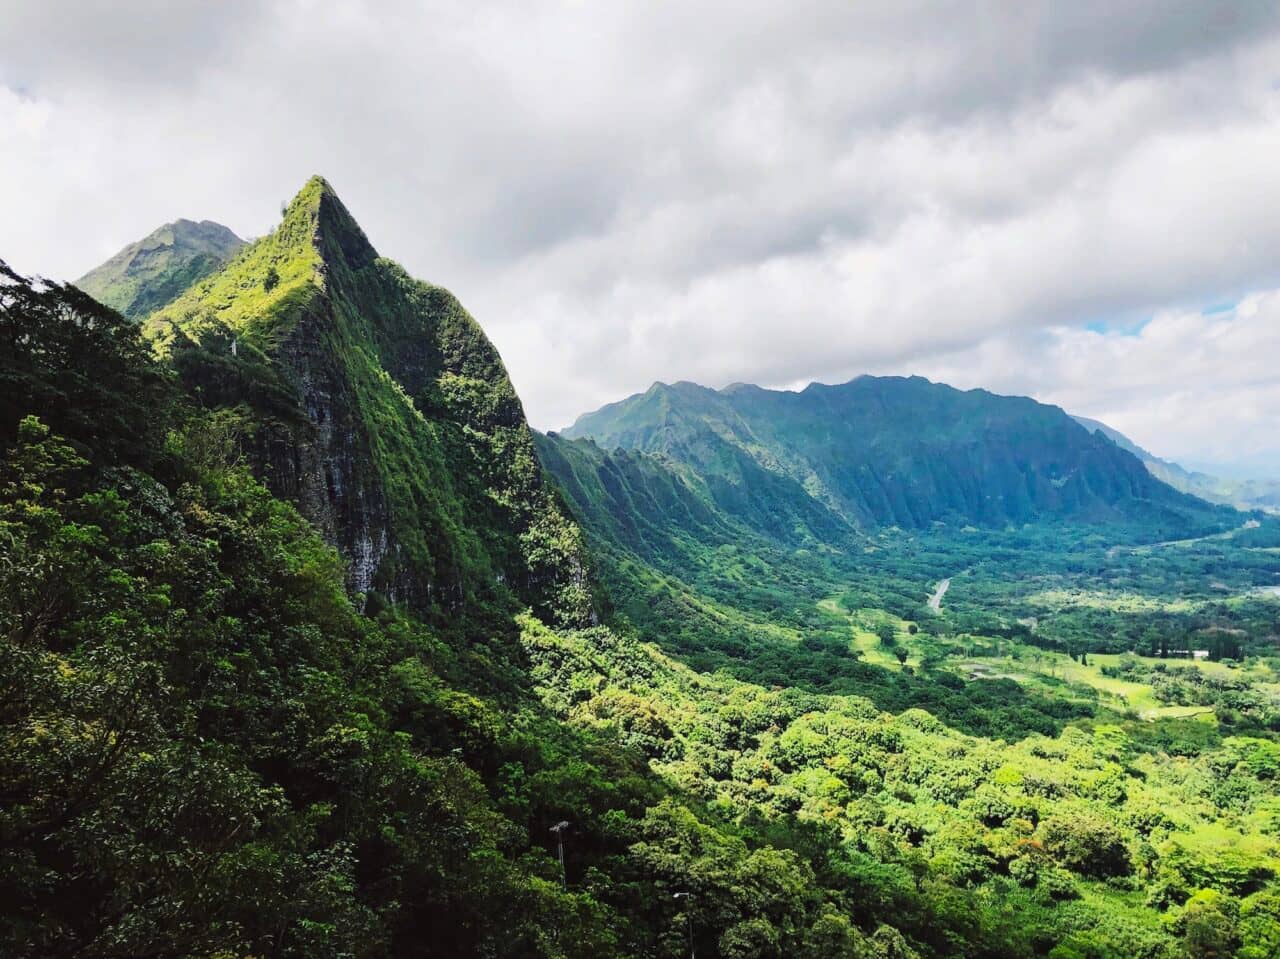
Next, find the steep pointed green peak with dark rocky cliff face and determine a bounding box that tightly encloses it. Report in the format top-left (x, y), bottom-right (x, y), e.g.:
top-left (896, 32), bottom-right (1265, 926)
top-left (145, 178), bottom-right (591, 622)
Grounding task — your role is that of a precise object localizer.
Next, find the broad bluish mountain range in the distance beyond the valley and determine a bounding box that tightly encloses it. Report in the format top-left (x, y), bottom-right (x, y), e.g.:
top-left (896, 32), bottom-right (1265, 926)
top-left (563, 376), bottom-right (1211, 542)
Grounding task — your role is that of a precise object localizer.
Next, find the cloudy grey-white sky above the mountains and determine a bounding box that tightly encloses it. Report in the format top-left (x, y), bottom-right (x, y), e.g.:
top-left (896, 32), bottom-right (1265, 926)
top-left (0, 0), bottom-right (1280, 476)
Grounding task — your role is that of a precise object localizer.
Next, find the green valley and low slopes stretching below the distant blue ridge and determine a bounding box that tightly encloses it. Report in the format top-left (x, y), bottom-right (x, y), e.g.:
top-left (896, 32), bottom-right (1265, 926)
top-left (540, 412), bottom-right (1280, 956)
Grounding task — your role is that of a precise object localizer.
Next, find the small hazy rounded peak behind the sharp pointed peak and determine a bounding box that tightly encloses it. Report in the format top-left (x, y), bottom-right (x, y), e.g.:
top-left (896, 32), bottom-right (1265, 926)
top-left (76, 220), bottom-right (244, 319)
